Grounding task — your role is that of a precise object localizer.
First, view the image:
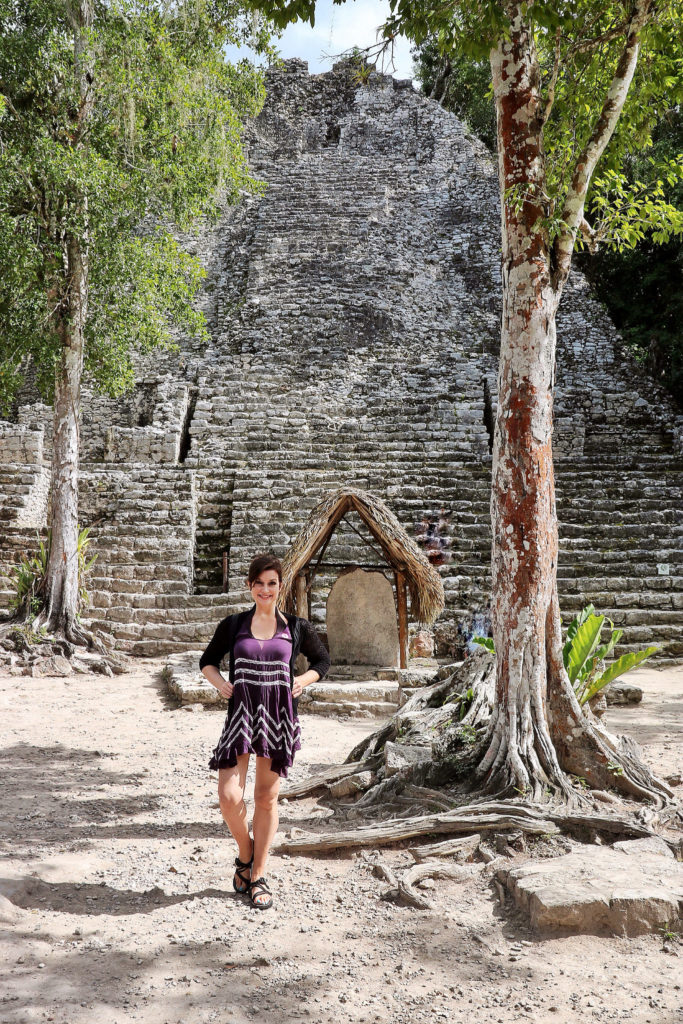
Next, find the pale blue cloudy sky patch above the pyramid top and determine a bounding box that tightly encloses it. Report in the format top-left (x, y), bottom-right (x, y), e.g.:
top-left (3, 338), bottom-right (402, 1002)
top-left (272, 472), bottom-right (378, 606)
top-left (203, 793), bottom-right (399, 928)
top-left (229, 0), bottom-right (413, 78)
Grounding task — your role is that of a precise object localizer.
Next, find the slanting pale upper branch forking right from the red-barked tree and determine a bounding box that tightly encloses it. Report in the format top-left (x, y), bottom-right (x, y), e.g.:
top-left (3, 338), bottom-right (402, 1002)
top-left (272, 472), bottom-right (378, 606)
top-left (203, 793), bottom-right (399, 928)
top-left (553, 0), bottom-right (654, 291)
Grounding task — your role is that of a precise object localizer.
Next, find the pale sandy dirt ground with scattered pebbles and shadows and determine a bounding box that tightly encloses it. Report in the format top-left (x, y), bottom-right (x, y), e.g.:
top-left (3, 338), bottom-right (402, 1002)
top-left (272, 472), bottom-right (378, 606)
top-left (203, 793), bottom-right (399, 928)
top-left (0, 662), bottom-right (683, 1024)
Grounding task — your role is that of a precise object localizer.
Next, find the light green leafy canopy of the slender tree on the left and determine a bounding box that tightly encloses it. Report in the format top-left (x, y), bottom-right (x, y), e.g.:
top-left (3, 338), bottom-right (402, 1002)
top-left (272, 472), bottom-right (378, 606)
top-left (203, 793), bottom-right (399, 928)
top-left (0, 0), bottom-right (272, 410)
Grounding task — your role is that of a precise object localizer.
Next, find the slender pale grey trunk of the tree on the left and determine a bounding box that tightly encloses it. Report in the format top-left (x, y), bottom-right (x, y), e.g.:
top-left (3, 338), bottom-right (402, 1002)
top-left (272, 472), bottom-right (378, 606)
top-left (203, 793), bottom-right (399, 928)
top-left (36, 0), bottom-right (93, 644)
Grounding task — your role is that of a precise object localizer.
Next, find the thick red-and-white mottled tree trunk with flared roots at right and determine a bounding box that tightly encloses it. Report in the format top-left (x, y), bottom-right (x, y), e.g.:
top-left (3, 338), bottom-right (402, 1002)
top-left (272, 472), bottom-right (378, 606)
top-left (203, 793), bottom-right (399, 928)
top-left (477, 6), bottom-right (671, 800)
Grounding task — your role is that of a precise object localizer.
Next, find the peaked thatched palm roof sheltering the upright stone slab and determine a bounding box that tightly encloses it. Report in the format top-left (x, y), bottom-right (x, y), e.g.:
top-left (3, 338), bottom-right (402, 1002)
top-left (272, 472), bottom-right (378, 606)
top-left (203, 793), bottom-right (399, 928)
top-left (280, 486), bottom-right (444, 623)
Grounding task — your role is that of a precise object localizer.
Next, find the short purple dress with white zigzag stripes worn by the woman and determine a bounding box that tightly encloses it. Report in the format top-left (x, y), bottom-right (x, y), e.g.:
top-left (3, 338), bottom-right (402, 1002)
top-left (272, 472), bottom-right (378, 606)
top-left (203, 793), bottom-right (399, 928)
top-left (209, 618), bottom-right (301, 778)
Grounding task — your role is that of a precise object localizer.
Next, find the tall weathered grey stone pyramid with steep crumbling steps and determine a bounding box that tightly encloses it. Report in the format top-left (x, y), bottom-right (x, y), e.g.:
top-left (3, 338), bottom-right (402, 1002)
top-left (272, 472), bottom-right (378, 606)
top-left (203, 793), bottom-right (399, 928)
top-left (0, 60), bottom-right (683, 658)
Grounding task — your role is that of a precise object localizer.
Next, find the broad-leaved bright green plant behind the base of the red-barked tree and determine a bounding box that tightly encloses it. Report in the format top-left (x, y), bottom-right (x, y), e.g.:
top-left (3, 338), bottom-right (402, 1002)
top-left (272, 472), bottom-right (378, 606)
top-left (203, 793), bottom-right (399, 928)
top-left (562, 604), bottom-right (657, 705)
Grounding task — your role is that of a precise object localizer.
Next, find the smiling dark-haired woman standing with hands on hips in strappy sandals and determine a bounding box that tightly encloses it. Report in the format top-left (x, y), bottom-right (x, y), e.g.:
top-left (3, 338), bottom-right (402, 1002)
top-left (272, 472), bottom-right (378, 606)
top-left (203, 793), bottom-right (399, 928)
top-left (200, 555), bottom-right (330, 910)
